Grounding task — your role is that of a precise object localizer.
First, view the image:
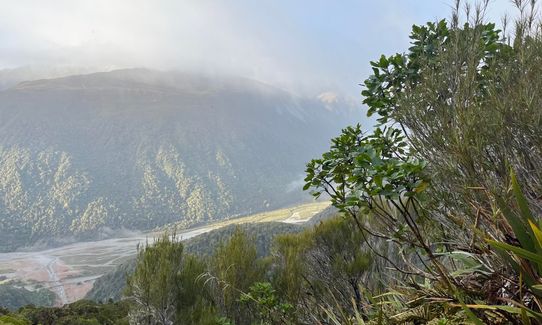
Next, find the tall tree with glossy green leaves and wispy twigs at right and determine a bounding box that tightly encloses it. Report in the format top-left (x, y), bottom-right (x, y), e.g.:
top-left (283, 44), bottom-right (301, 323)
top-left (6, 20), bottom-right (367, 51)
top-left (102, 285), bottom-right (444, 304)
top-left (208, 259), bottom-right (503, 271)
top-left (305, 0), bottom-right (542, 321)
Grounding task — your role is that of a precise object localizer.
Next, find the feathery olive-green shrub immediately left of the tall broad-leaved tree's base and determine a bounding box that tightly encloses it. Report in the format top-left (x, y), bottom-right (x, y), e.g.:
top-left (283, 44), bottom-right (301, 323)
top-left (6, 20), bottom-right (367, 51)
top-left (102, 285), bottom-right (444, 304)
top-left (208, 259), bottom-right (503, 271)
top-left (274, 216), bottom-right (376, 322)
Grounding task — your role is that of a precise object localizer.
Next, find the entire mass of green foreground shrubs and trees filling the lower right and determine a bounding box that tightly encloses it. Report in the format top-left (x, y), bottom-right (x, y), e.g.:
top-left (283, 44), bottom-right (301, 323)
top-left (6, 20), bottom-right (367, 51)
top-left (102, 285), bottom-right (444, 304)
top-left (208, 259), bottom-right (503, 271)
top-left (5, 0), bottom-right (542, 325)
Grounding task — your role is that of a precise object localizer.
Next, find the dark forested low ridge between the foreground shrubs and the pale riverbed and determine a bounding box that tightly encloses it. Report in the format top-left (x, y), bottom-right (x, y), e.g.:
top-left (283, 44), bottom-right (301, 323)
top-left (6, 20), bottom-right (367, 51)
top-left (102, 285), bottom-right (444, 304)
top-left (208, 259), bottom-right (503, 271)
top-left (86, 222), bottom-right (303, 302)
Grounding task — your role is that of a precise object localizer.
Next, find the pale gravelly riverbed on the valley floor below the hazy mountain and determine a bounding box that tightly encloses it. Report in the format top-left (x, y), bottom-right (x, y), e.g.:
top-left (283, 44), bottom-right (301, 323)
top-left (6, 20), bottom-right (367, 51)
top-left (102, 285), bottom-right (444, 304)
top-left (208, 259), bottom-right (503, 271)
top-left (0, 202), bottom-right (329, 306)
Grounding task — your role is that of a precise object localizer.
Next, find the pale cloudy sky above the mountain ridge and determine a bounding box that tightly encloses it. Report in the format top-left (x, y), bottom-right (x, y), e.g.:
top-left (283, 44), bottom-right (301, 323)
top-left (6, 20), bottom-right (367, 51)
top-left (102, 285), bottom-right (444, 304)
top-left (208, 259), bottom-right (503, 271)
top-left (0, 0), bottom-right (524, 97)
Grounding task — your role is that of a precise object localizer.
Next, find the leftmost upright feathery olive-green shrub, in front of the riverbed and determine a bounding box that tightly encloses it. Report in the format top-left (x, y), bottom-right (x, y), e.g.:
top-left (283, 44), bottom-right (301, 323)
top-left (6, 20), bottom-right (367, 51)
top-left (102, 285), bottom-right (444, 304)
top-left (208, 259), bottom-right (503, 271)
top-left (126, 234), bottom-right (217, 324)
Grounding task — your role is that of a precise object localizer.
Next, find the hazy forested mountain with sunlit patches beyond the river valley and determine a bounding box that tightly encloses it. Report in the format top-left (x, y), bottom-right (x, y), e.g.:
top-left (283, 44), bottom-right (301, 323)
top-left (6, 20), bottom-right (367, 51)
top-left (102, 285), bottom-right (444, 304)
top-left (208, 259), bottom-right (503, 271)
top-left (0, 69), bottom-right (352, 251)
